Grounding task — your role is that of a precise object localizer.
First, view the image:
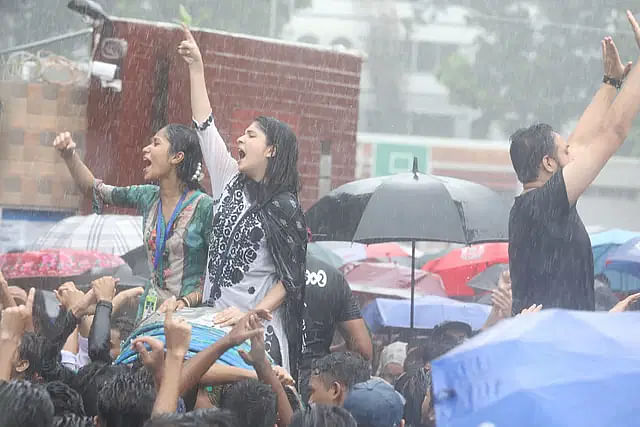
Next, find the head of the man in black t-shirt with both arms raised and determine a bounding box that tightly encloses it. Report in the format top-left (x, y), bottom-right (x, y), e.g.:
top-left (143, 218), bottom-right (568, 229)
top-left (509, 123), bottom-right (571, 184)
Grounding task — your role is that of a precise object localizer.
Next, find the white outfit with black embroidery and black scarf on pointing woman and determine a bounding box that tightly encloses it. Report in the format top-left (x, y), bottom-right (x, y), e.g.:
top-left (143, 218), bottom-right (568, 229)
top-left (194, 115), bottom-right (307, 370)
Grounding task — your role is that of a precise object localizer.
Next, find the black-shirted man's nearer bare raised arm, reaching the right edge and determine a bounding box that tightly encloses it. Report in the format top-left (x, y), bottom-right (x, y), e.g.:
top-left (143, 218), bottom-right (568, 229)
top-left (563, 11), bottom-right (640, 205)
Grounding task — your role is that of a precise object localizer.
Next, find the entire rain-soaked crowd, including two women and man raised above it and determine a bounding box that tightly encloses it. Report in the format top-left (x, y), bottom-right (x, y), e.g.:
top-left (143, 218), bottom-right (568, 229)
top-left (0, 8), bottom-right (640, 427)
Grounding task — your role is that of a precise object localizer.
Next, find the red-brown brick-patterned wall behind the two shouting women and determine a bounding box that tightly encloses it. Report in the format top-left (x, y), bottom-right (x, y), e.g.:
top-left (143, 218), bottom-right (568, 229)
top-left (87, 20), bottom-right (361, 212)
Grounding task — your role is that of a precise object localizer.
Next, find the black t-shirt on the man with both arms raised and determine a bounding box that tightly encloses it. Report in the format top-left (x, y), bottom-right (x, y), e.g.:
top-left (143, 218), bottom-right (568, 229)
top-left (509, 171), bottom-right (595, 313)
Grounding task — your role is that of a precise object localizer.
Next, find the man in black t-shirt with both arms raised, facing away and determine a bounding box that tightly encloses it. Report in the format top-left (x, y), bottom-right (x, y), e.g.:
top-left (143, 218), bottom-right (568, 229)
top-left (509, 16), bottom-right (640, 313)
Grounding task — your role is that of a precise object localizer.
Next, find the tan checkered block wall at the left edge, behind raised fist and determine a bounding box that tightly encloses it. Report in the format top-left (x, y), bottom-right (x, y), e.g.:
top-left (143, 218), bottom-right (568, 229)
top-left (0, 81), bottom-right (87, 210)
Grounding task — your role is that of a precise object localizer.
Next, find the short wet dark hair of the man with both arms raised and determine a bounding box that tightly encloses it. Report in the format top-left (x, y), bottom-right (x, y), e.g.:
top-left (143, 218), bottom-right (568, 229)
top-left (509, 123), bottom-right (556, 184)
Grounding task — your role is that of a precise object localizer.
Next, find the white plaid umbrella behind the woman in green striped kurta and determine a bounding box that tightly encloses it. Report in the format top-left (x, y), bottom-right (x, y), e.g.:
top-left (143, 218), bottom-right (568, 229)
top-left (32, 214), bottom-right (142, 255)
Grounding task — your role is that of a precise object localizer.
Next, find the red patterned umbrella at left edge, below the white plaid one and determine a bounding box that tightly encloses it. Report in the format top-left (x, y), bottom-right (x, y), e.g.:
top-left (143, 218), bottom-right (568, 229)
top-left (0, 249), bottom-right (124, 279)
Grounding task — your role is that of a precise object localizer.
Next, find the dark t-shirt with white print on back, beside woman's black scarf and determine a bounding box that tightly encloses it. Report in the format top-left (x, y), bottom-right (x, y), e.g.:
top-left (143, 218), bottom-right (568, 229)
top-left (299, 256), bottom-right (362, 402)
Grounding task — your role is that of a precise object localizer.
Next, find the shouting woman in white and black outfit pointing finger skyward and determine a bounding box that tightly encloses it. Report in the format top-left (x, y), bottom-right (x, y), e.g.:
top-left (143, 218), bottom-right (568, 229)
top-left (178, 27), bottom-right (307, 372)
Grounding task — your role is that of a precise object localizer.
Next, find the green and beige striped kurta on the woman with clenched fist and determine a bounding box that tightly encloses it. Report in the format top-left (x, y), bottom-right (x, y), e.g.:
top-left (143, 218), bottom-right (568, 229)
top-left (93, 180), bottom-right (213, 317)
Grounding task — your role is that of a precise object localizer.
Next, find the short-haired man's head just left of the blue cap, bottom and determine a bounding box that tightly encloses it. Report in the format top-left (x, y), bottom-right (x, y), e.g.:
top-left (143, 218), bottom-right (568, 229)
top-left (309, 352), bottom-right (371, 406)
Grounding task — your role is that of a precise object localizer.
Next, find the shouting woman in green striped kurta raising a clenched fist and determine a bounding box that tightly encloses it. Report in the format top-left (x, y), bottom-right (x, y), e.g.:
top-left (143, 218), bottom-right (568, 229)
top-left (53, 124), bottom-right (213, 319)
